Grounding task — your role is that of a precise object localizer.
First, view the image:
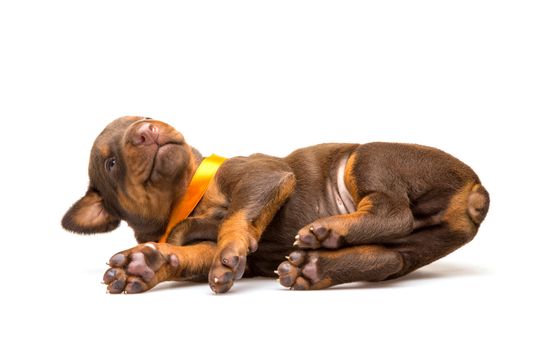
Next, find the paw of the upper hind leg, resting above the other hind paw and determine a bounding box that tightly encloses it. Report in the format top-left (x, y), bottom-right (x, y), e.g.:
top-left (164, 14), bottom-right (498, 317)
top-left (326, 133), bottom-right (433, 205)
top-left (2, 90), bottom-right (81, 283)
top-left (293, 220), bottom-right (343, 249)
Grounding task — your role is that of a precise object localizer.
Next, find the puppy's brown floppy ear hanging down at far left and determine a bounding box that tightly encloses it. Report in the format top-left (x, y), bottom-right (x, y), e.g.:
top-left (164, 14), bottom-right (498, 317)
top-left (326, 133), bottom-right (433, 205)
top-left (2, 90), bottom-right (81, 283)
top-left (62, 188), bottom-right (120, 233)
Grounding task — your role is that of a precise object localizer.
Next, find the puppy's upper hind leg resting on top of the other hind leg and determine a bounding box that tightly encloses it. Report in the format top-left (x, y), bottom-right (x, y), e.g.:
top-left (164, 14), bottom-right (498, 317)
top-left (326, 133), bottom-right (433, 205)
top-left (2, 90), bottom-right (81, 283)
top-left (294, 192), bottom-right (414, 249)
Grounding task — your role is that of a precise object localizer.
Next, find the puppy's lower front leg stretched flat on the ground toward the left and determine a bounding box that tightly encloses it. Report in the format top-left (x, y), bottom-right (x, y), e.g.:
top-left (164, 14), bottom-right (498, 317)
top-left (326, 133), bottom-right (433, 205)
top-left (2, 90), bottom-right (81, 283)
top-left (103, 242), bottom-right (216, 293)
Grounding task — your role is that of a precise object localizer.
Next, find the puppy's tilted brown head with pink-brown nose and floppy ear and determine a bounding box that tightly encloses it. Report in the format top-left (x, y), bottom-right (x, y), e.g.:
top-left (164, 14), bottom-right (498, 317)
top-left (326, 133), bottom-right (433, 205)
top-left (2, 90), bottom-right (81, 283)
top-left (62, 117), bottom-right (200, 241)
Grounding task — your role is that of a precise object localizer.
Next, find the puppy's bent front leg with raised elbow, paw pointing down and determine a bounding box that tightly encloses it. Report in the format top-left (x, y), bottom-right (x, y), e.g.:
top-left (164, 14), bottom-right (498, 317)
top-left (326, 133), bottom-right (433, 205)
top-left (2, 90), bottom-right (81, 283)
top-left (209, 171), bottom-right (295, 293)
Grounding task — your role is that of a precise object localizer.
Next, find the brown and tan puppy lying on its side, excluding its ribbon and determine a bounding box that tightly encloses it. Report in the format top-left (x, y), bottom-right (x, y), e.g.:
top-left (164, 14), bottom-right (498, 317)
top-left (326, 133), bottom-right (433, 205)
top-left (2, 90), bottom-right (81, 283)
top-left (62, 117), bottom-right (489, 293)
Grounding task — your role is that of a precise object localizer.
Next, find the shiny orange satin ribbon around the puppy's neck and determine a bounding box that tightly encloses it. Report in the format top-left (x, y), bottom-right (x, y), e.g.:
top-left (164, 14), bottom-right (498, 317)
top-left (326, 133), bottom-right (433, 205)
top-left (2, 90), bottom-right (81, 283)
top-left (159, 154), bottom-right (226, 243)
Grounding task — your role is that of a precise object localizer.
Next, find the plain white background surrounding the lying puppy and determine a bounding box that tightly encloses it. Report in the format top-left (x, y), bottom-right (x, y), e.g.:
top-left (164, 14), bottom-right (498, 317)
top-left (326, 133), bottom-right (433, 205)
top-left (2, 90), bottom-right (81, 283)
top-left (0, 0), bottom-right (541, 349)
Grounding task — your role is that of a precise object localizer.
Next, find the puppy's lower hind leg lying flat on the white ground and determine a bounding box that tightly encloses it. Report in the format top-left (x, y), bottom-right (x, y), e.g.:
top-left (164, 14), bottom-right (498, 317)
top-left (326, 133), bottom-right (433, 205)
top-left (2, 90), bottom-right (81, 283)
top-left (276, 245), bottom-right (403, 290)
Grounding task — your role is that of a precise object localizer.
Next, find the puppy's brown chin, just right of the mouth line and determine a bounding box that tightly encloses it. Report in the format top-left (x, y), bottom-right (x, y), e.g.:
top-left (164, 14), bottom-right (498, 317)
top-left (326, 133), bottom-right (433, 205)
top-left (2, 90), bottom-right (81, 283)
top-left (150, 143), bottom-right (186, 185)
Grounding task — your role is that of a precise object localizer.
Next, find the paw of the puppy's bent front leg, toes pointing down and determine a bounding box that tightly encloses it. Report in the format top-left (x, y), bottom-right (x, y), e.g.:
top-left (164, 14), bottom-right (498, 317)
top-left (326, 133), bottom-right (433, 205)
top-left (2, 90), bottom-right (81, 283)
top-left (209, 242), bottom-right (250, 293)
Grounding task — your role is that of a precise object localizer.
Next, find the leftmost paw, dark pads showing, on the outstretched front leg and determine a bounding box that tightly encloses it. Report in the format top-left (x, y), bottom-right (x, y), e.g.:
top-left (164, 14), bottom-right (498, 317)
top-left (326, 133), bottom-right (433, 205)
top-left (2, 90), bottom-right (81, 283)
top-left (103, 243), bottom-right (179, 294)
